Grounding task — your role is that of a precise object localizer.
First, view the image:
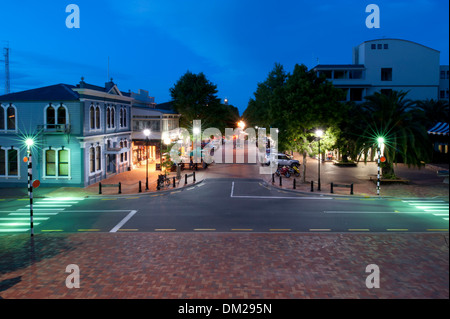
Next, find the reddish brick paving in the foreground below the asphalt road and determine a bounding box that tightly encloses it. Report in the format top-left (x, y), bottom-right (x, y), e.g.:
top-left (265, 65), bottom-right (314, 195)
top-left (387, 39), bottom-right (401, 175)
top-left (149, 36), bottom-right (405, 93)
top-left (0, 233), bottom-right (449, 299)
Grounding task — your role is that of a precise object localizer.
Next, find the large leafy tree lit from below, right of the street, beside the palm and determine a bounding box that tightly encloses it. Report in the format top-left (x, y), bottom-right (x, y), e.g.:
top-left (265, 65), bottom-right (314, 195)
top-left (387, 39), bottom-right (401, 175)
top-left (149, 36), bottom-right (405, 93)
top-left (271, 64), bottom-right (346, 182)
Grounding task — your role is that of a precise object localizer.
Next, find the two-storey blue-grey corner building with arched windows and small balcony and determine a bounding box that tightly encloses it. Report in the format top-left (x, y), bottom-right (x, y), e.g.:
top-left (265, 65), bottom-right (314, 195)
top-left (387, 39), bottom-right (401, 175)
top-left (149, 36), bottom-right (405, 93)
top-left (0, 78), bottom-right (133, 187)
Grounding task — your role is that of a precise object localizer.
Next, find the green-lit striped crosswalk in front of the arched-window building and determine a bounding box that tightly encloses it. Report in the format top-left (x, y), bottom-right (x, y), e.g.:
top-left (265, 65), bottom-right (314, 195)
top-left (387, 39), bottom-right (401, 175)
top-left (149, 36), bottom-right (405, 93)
top-left (0, 197), bottom-right (84, 233)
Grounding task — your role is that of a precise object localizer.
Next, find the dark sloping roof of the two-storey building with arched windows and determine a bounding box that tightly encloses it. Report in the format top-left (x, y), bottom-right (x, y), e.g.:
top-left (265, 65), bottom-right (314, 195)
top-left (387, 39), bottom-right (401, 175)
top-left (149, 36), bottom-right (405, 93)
top-left (0, 83), bottom-right (79, 101)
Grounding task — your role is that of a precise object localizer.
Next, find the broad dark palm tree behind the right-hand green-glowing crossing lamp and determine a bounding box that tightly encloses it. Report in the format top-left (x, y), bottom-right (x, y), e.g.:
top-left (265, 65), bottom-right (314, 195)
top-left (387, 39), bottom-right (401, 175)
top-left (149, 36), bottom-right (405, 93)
top-left (357, 91), bottom-right (432, 178)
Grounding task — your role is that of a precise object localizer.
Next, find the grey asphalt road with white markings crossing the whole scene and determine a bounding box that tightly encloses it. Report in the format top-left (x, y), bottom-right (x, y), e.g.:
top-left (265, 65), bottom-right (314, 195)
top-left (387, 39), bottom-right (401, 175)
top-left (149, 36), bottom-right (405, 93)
top-left (0, 178), bottom-right (449, 234)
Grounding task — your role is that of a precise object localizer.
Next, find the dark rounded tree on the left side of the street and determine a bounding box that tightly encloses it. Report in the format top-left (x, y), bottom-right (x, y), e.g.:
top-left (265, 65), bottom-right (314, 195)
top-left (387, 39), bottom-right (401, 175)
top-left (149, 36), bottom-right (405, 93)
top-left (170, 71), bottom-right (223, 127)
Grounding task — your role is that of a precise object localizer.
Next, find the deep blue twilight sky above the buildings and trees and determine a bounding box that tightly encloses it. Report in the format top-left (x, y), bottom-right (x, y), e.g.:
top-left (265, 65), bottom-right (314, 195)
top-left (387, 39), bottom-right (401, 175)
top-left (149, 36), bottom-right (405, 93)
top-left (0, 0), bottom-right (449, 114)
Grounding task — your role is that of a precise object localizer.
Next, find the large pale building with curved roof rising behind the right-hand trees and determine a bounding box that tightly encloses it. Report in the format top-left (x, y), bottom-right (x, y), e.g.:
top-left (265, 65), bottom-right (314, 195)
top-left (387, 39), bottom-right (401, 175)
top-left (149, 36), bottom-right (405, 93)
top-left (313, 39), bottom-right (442, 102)
